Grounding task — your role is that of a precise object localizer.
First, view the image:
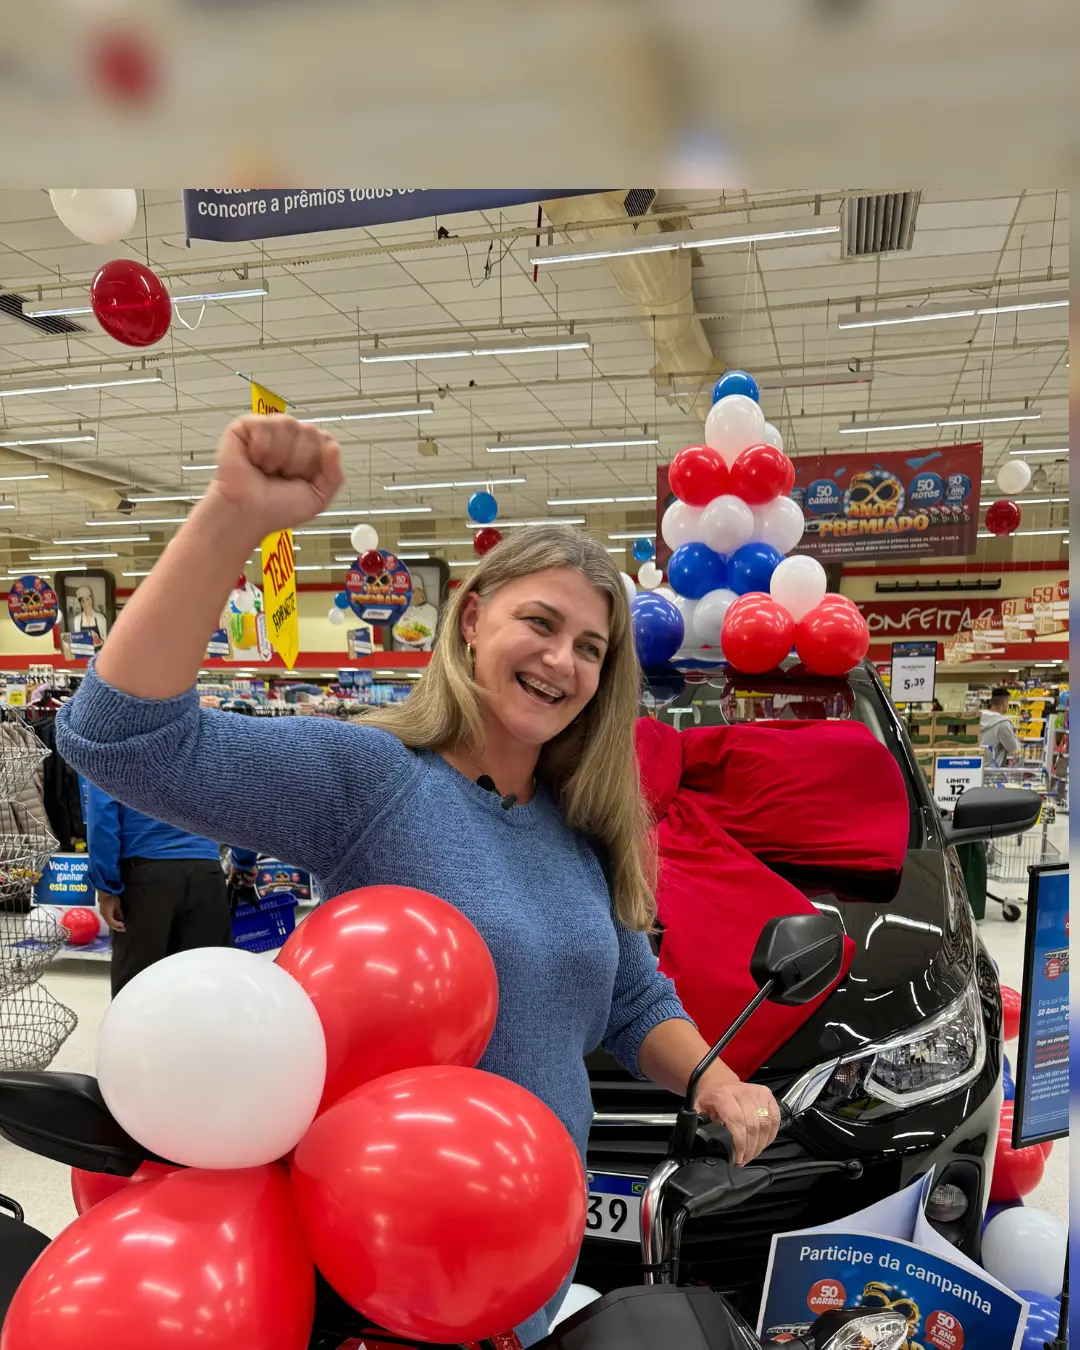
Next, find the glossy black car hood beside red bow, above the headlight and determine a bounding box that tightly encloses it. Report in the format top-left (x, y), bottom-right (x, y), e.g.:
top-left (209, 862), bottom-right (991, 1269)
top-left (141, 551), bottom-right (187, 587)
top-left (765, 810), bottom-right (975, 1073)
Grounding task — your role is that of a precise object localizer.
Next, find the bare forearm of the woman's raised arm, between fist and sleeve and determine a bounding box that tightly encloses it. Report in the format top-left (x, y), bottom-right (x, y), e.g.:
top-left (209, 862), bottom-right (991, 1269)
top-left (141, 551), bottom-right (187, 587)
top-left (96, 493), bottom-right (259, 698)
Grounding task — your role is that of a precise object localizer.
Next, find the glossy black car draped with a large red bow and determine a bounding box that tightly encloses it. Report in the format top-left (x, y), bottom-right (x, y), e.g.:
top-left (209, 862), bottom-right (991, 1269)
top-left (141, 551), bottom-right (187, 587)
top-left (575, 663), bottom-right (1015, 1318)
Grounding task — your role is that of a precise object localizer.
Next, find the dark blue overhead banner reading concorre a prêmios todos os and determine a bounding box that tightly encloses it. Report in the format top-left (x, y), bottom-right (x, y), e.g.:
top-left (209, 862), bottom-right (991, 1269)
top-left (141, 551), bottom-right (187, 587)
top-left (184, 188), bottom-right (597, 243)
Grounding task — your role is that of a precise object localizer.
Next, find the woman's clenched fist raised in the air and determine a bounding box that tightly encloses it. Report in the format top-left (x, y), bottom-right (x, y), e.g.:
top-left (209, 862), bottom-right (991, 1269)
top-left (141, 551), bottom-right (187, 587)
top-left (208, 414), bottom-right (342, 537)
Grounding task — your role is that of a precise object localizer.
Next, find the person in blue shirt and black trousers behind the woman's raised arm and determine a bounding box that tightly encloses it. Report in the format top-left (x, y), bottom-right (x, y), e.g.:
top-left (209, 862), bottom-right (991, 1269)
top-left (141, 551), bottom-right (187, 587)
top-left (84, 780), bottom-right (232, 998)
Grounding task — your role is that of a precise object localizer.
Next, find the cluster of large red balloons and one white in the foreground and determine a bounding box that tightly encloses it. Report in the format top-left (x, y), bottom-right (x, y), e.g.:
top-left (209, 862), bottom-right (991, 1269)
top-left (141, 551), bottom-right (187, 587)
top-left (3, 886), bottom-right (586, 1350)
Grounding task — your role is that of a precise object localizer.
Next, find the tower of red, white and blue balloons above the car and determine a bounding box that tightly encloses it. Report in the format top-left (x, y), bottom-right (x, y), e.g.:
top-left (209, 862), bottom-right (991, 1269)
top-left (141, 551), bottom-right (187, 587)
top-left (632, 370), bottom-right (869, 675)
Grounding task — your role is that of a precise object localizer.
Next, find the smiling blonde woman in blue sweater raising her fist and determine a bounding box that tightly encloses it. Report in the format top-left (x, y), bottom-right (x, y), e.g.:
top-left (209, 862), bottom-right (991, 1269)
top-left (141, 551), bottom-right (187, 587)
top-left (57, 416), bottom-right (780, 1346)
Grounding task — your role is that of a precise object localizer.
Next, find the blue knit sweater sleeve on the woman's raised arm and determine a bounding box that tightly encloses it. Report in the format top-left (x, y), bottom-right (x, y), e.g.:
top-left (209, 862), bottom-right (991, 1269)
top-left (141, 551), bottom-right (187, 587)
top-left (57, 666), bottom-right (419, 876)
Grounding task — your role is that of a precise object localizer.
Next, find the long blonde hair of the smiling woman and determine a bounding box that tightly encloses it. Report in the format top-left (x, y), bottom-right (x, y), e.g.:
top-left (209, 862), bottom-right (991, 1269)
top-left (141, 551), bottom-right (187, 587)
top-left (365, 525), bottom-right (656, 932)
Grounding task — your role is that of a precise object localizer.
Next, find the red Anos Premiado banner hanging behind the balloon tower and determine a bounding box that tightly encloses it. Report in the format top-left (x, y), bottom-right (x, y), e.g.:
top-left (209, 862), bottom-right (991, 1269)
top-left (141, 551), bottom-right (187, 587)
top-left (783, 441), bottom-right (983, 562)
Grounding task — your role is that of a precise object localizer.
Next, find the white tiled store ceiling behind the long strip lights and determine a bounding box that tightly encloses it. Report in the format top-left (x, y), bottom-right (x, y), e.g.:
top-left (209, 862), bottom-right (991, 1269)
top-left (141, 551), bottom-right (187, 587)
top-left (0, 189), bottom-right (1068, 581)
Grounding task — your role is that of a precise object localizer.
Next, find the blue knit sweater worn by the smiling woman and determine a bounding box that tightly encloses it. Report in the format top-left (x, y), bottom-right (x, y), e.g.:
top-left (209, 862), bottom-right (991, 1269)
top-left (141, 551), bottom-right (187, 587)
top-left (57, 668), bottom-right (686, 1345)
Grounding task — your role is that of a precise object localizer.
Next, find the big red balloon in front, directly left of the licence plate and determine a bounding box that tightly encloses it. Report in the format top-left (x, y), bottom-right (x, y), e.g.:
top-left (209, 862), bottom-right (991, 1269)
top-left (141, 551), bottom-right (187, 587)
top-left (291, 1068), bottom-right (586, 1343)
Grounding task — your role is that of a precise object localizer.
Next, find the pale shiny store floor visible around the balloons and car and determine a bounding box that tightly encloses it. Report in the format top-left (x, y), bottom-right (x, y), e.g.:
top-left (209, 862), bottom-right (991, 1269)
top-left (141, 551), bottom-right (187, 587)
top-left (0, 880), bottom-right (1068, 1235)
